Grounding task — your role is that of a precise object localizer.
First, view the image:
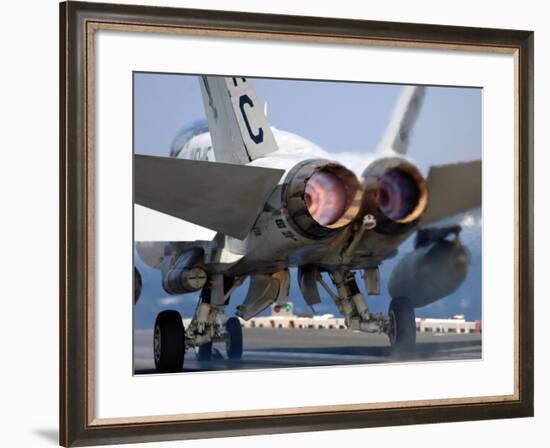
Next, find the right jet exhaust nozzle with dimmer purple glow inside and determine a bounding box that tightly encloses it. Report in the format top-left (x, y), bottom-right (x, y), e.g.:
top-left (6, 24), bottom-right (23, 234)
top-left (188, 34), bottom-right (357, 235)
top-left (362, 157), bottom-right (428, 233)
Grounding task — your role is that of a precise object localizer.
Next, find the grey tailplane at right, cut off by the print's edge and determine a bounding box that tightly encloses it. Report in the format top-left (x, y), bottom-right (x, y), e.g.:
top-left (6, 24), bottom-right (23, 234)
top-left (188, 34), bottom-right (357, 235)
top-left (420, 160), bottom-right (481, 226)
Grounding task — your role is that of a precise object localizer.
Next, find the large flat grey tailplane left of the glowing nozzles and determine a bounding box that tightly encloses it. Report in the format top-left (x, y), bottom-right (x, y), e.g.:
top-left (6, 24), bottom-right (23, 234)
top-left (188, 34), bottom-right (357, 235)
top-left (134, 155), bottom-right (284, 239)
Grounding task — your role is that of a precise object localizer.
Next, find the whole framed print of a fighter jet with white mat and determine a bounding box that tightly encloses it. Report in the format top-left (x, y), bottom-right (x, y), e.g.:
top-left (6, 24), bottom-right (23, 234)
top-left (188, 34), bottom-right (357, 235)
top-left (60, 2), bottom-right (533, 446)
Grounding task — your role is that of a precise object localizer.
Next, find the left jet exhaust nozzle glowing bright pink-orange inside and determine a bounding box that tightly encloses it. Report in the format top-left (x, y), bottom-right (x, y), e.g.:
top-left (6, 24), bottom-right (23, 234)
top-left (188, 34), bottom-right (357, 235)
top-left (282, 159), bottom-right (361, 238)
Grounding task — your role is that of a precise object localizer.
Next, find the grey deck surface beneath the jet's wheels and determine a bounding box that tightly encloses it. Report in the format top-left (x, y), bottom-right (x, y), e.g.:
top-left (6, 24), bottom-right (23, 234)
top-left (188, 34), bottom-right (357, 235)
top-left (134, 328), bottom-right (481, 374)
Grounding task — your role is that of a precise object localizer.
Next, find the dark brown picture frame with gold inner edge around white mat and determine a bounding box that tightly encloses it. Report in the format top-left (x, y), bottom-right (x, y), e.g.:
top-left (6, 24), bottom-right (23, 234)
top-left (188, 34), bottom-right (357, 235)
top-left (59, 2), bottom-right (534, 446)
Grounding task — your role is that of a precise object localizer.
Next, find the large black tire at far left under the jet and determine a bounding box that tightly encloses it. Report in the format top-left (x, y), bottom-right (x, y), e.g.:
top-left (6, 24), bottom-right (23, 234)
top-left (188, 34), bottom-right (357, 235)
top-left (153, 310), bottom-right (185, 373)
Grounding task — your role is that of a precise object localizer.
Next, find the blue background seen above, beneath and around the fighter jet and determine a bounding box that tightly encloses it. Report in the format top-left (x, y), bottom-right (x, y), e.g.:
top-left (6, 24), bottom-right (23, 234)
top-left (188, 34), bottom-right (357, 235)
top-left (134, 73), bottom-right (482, 328)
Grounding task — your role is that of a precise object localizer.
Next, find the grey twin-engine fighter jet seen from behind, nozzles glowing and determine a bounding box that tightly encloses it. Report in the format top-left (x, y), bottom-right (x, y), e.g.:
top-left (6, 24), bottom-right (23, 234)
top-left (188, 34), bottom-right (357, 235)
top-left (134, 76), bottom-right (481, 372)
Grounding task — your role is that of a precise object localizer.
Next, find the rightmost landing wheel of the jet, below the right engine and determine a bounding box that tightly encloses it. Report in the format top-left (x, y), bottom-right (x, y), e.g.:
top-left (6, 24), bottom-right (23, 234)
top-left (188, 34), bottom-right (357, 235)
top-left (388, 297), bottom-right (416, 353)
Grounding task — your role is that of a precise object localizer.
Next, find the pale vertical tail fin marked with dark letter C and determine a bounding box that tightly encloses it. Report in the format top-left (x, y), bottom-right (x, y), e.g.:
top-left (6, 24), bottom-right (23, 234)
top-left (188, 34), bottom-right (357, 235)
top-left (200, 76), bottom-right (277, 165)
